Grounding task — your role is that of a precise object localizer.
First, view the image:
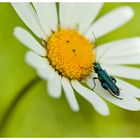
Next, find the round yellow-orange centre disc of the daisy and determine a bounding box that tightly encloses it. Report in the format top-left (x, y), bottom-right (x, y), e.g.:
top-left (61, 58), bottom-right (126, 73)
top-left (47, 29), bottom-right (95, 80)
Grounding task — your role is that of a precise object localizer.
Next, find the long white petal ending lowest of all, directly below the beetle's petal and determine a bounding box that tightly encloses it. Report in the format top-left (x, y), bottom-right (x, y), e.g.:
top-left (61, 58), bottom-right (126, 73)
top-left (71, 80), bottom-right (109, 115)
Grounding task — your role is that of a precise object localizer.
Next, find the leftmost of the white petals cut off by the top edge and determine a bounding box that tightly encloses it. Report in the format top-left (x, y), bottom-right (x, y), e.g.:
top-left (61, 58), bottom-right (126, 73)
top-left (12, 3), bottom-right (45, 38)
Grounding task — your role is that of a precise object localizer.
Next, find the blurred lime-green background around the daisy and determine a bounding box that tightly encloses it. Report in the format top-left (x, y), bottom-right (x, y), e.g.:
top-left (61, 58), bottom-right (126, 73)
top-left (0, 3), bottom-right (140, 137)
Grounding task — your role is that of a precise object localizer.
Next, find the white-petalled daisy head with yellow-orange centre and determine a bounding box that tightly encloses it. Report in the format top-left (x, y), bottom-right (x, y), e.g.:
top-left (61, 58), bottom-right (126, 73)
top-left (12, 3), bottom-right (140, 115)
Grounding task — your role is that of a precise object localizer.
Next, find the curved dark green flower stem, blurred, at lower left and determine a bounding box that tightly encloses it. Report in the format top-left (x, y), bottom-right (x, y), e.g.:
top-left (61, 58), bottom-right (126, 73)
top-left (0, 76), bottom-right (41, 134)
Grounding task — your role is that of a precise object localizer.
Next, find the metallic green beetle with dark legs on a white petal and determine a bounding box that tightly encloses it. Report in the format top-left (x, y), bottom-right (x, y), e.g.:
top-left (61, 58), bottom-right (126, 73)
top-left (93, 34), bottom-right (122, 99)
